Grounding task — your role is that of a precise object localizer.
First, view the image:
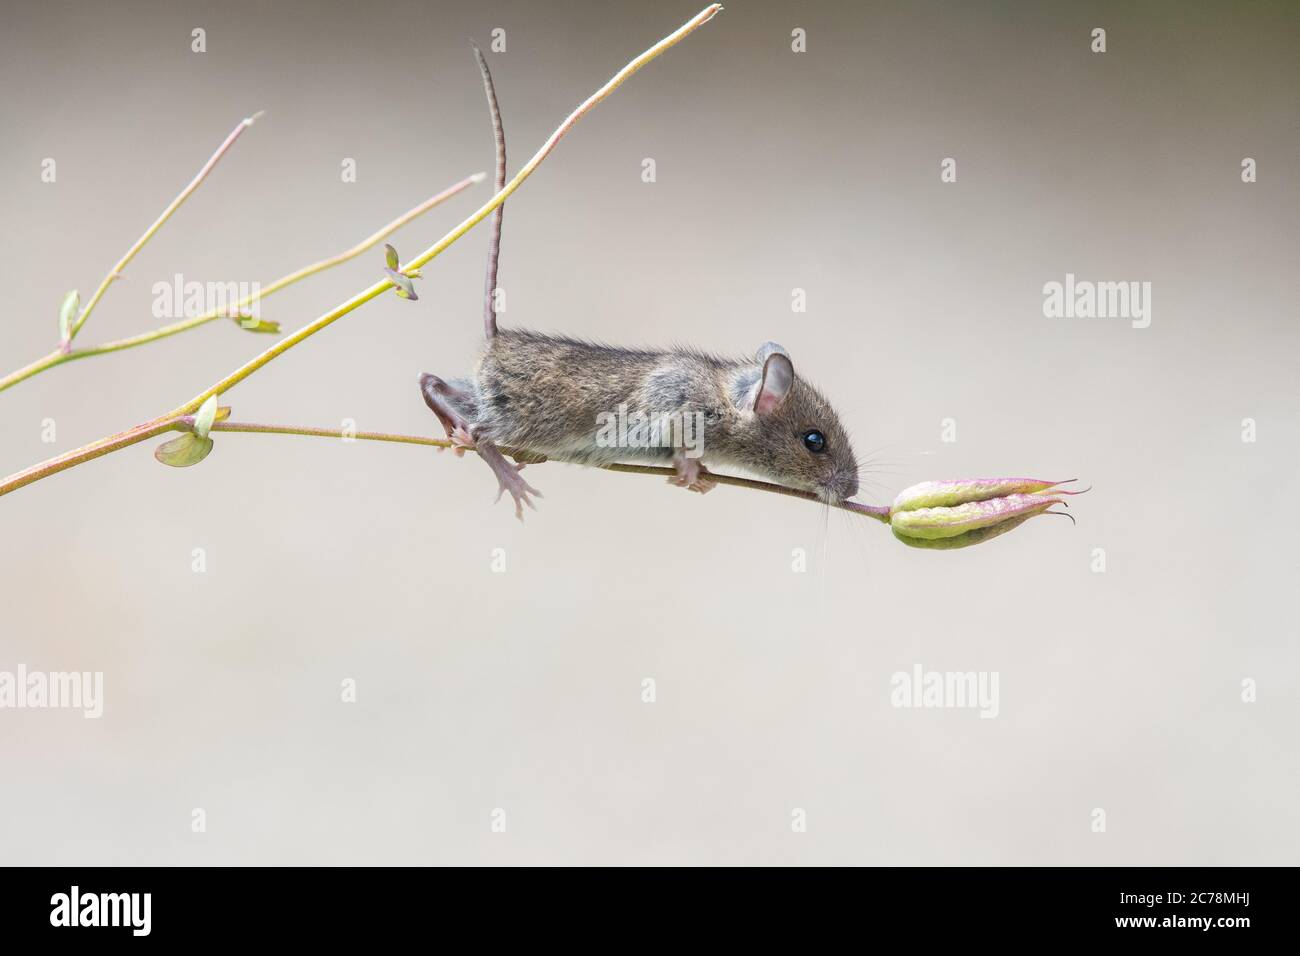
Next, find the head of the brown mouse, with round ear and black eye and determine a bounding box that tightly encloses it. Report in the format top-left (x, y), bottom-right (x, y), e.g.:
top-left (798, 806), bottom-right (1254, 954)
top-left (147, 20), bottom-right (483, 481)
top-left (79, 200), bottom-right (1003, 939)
top-left (738, 342), bottom-right (858, 502)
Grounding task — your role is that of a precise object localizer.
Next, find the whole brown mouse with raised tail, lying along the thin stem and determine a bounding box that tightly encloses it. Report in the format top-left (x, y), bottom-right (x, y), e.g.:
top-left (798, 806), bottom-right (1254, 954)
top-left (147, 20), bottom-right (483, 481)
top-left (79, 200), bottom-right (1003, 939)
top-left (419, 47), bottom-right (858, 519)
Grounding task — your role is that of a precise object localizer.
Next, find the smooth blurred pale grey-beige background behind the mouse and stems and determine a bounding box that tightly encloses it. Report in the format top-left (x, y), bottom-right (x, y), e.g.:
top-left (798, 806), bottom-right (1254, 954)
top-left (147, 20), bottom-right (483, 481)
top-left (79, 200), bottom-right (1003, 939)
top-left (0, 0), bottom-right (1300, 864)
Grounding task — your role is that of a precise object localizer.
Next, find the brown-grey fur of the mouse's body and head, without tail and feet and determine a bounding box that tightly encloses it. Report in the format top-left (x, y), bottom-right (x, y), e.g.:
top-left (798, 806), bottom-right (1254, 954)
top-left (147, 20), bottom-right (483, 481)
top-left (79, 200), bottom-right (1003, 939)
top-left (436, 329), bottom-right (858, 502)
